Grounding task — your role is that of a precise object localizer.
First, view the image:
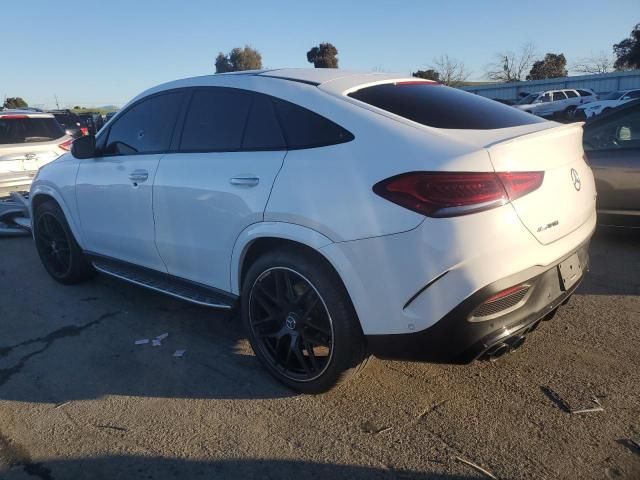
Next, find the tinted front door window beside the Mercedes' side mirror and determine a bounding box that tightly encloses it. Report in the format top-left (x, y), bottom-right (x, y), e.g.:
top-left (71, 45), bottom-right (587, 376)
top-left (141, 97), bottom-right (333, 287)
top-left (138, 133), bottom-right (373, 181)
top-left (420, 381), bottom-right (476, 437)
top-left (105, 93), bottom-right (182, 155)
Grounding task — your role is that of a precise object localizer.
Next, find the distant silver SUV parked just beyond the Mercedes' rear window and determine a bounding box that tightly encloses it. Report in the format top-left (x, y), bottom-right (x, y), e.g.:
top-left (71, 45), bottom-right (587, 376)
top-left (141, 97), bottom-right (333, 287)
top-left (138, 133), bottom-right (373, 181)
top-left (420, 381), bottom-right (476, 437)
top-left (514, 88), bottom-right (598, 120)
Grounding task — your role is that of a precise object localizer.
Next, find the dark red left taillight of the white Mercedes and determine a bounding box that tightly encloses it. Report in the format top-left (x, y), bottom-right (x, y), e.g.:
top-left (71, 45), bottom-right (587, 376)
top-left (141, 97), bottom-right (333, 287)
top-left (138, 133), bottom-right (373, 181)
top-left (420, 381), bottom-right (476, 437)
top-left (373, 172), bottom-right (544, 217)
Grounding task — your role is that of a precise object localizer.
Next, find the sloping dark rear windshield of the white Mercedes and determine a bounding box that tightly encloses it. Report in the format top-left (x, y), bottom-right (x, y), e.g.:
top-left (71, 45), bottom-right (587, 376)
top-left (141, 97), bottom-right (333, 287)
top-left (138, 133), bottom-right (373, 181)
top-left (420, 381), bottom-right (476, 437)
top-left (349, 83), bottom-right (545, 130)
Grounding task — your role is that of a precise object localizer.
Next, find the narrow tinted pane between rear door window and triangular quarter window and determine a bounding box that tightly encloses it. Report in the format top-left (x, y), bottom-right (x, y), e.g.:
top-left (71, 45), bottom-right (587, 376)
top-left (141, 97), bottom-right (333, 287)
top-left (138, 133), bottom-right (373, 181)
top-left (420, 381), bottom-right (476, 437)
top-left (242, 94), bottom-right (286, 150)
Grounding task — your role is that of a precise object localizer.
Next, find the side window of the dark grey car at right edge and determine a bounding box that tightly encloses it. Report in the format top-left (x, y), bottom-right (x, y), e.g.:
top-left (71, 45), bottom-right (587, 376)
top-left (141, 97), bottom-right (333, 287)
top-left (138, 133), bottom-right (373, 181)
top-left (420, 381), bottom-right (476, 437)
top-left (584, 107), bottom-right (640, 151)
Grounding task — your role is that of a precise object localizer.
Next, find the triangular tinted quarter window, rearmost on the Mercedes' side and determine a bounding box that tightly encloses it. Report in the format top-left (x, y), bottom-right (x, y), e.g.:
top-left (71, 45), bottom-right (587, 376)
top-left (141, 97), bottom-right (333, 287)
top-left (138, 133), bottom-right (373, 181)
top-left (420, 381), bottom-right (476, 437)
top-left (274, 100), bottom-right (353, 149)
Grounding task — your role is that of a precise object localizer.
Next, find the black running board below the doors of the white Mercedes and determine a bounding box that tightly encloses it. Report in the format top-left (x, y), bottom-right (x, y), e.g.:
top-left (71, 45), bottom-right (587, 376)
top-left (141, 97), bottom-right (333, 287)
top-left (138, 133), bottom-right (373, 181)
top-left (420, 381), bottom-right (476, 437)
top-left (89, 254), bottom-right (236, 310)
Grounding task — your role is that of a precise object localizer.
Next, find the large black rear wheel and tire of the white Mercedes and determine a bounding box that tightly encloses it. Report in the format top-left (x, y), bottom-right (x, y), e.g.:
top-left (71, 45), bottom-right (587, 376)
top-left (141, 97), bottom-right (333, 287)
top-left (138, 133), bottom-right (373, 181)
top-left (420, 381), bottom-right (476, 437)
top-left (241, 248), bottom-right (368, 394)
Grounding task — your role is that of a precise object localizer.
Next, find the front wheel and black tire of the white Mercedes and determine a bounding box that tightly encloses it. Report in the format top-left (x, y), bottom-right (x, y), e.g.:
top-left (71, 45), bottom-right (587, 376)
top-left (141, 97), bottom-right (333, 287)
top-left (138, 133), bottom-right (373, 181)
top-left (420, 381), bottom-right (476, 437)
top-left (33, 200), bottom-right (96, 285)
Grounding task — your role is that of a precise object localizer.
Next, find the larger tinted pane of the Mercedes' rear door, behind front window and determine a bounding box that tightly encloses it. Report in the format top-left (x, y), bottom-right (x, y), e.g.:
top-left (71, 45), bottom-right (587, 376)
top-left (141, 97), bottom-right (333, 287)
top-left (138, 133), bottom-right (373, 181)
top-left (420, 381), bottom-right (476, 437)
top-left (180, 88), bottom-right (251, 151)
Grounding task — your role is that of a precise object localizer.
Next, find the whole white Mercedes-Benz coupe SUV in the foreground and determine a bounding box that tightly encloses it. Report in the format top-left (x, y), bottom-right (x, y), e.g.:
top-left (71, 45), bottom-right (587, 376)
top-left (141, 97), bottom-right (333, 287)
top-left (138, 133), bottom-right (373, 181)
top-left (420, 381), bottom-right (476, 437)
top-left (31, 69), bottom-right (596, 392)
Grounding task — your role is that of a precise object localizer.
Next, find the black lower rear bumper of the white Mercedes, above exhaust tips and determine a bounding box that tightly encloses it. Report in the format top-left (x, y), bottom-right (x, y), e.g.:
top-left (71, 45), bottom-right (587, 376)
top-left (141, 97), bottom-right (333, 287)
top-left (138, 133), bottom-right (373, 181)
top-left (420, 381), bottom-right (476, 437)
top-left (366, 239), bottom-right (590, 363)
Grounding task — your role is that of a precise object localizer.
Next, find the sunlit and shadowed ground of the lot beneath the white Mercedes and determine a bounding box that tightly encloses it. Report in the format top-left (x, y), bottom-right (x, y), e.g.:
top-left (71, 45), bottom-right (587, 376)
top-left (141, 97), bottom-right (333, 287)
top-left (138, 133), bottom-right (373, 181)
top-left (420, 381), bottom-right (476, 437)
top-left (0, 232), bottom-right (640, 480)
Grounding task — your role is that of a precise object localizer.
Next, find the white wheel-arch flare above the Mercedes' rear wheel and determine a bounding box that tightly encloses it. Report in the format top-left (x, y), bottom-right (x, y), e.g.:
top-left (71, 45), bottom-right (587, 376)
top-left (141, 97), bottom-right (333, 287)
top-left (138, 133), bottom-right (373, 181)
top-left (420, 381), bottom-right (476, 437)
top-left (230, 222), bottom-right (333, 295)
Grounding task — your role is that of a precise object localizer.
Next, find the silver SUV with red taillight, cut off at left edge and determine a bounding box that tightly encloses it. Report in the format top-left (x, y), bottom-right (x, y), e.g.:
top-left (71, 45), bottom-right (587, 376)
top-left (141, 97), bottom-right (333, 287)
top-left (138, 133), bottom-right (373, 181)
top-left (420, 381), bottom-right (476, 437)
top-left (0, 110), bottom-right (73, 197)
